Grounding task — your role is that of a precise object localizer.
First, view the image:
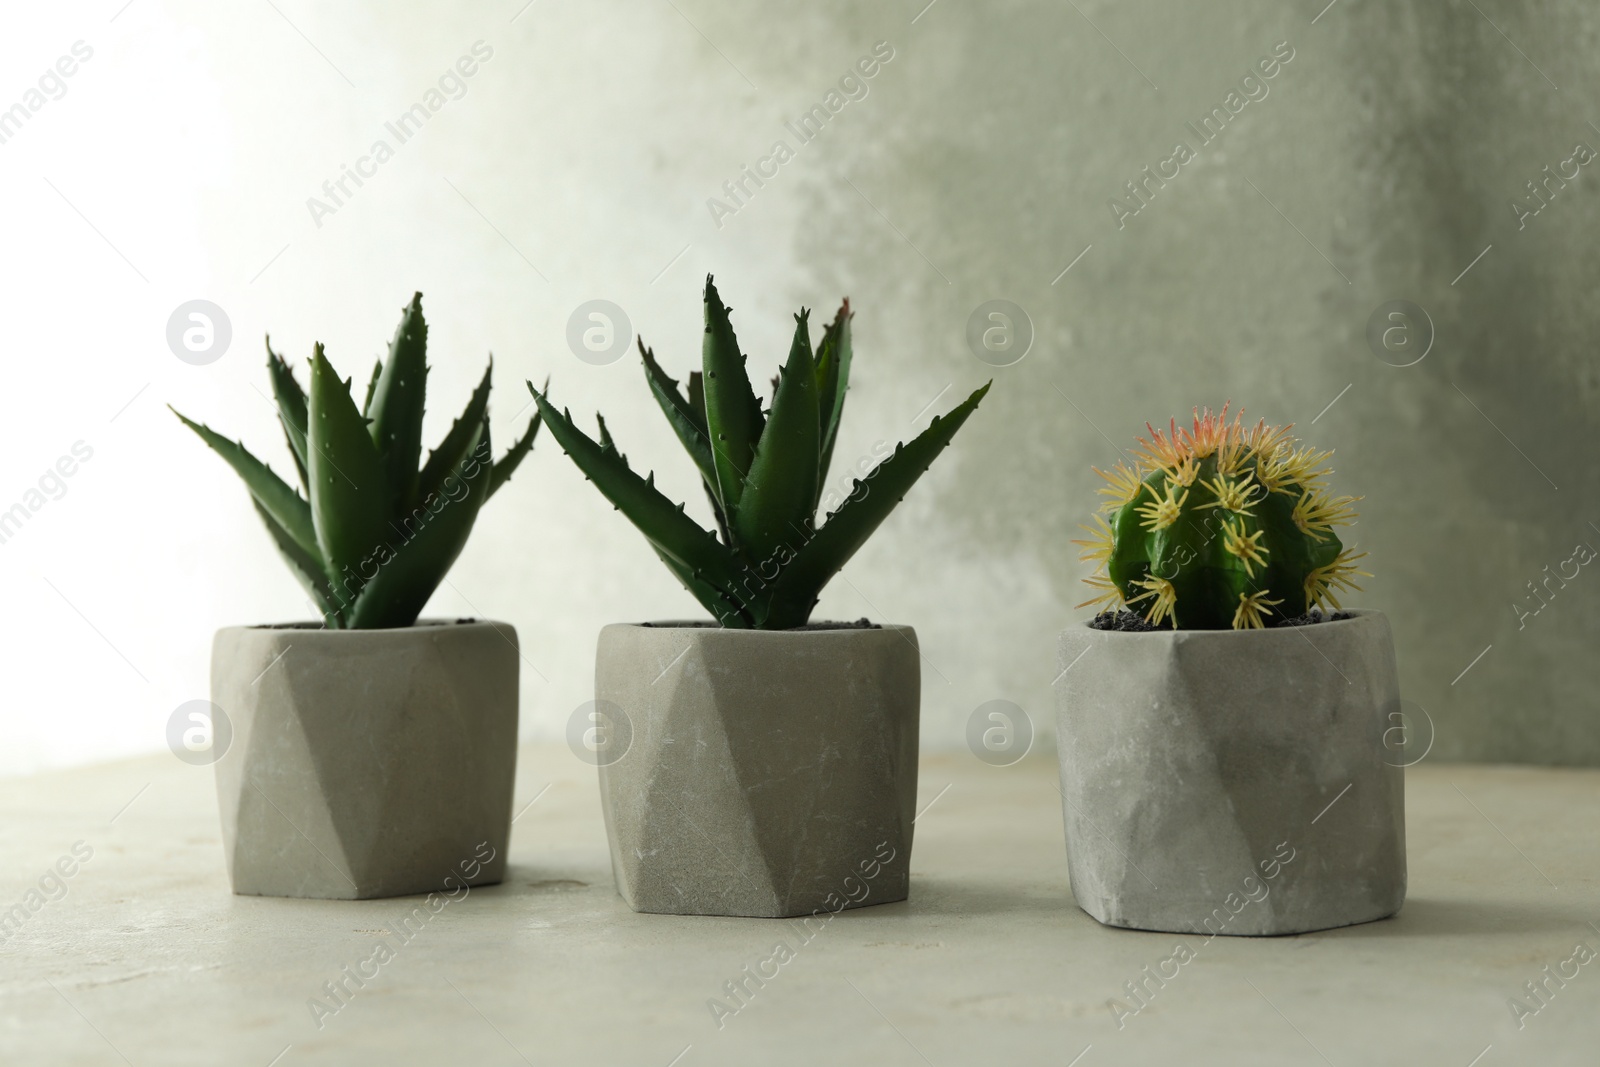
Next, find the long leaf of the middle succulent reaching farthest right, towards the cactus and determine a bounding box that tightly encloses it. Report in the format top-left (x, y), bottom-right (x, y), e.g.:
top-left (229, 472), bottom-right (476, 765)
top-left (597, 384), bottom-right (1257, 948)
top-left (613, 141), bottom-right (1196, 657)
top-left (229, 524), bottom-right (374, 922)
top-left (757, 382), bottom-right (994, 630)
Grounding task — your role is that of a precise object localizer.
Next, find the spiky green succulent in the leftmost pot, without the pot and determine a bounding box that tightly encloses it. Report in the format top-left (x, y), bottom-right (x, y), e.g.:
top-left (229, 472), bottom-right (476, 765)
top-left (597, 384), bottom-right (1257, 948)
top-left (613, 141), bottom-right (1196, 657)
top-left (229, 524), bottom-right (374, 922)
top-left (173, 293), bottom-right (539, 630)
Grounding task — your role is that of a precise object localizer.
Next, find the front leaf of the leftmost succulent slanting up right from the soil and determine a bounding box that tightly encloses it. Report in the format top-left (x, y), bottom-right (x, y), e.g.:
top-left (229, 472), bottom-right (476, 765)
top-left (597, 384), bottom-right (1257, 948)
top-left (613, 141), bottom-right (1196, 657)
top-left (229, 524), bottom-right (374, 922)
top-left (350, 421), bottom-right (494, 630)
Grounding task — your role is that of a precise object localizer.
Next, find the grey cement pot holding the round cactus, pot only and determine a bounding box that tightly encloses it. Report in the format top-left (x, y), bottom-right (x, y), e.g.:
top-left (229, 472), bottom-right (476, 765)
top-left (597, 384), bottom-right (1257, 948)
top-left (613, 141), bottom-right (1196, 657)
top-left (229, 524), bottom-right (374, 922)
top-left (1056, 611), bottom-right (1406, 934)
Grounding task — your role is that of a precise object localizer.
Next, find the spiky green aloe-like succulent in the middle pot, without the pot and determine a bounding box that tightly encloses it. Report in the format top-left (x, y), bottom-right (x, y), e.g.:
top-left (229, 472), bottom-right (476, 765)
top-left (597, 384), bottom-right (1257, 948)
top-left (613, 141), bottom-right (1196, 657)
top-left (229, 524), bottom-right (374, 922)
top-left (528, 277), bottom-right (989, 630)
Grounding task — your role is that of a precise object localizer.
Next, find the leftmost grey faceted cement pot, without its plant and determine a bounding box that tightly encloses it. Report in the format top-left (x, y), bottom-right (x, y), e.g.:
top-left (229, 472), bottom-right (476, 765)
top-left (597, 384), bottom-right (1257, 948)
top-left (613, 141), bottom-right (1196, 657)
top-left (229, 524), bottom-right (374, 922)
top-left (211, 621), bottom-right (518, 899)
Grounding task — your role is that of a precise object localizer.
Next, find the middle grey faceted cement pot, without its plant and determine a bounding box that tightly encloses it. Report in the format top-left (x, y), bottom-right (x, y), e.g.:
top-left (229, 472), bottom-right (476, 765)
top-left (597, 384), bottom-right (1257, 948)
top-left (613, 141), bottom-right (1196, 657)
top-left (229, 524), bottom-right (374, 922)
top-left (595, 622), bottom-right (922, 918)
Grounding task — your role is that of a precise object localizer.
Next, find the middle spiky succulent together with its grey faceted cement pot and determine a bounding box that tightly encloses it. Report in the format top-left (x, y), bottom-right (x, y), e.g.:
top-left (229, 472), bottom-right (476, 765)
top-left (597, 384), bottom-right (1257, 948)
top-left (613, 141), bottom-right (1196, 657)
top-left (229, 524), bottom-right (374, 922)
top-left (528, 278), bottom-right (989, 917)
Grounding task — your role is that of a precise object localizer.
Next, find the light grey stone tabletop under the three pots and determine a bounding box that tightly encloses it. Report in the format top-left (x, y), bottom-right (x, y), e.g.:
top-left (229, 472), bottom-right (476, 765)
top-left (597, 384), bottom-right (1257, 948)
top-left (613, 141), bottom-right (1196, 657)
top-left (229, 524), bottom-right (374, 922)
top-left (0, 745), bottom-right (1600, 1067)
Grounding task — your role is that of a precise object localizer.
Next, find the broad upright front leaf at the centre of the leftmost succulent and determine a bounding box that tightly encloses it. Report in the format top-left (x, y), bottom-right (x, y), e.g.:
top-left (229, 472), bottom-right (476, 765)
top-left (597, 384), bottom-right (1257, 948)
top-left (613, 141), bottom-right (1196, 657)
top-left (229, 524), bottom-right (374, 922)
top-left (306, 344), bottom-right (390, 598)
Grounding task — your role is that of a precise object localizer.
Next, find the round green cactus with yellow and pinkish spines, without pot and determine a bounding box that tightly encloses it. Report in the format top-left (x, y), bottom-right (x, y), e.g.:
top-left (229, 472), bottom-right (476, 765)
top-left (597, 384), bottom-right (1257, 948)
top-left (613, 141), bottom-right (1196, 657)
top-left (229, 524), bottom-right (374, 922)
top-left (1074, 405), bottom-right (1371, 630)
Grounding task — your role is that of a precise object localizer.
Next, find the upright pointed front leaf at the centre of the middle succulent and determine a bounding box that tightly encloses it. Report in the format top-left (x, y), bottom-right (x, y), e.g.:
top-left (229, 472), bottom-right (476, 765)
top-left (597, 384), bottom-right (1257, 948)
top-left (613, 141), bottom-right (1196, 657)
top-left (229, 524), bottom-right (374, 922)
top-left (733, 309), bottom-right (821, 561)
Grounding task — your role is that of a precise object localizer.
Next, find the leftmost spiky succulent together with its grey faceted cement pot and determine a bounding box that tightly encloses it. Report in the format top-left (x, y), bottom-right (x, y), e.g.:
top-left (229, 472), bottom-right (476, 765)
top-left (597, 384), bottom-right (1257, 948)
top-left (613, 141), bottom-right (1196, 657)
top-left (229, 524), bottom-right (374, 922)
top-left (174, 293), bottom-right (539, 899)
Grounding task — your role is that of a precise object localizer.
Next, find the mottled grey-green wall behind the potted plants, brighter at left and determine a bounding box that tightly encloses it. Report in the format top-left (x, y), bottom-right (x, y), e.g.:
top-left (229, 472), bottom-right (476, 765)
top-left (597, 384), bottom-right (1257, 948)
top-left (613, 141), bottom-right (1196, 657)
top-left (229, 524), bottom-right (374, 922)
top-left (0, 0), bottom-right (1600, 771)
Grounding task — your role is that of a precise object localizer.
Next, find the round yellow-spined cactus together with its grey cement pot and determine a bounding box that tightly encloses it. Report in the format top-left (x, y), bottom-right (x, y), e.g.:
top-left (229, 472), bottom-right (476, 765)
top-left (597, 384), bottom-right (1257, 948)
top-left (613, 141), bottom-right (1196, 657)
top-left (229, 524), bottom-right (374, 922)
top-left (1056, 405), bottom-right (1406, 934)
